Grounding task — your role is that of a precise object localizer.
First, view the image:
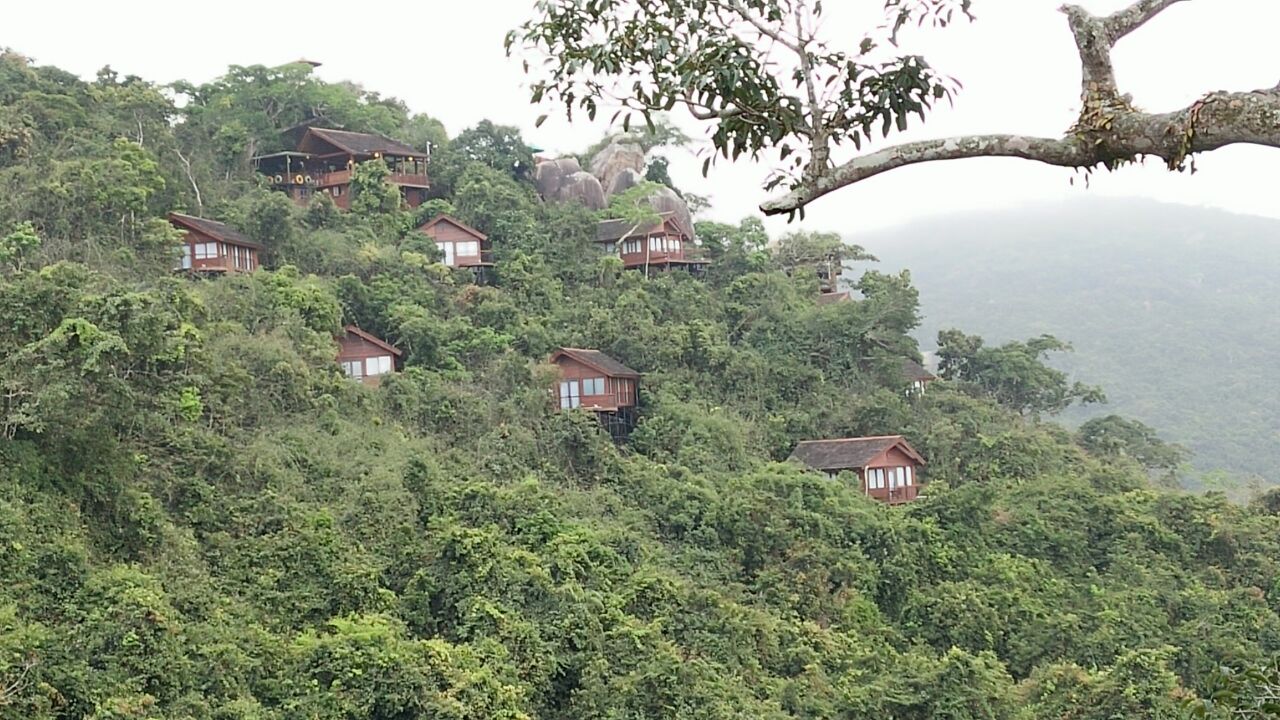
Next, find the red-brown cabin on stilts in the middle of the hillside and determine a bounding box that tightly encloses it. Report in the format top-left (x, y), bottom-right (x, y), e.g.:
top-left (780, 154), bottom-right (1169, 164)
top-left (550, 347), bottom-right (640, 438)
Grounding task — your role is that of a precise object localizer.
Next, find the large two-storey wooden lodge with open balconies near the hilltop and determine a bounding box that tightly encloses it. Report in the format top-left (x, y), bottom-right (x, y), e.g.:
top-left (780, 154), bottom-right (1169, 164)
top-left (253, 127), bottom-right (430, 210)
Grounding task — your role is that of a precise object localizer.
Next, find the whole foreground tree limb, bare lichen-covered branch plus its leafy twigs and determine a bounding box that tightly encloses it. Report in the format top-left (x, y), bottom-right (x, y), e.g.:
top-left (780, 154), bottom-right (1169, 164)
top-left (507, 0), bottom-right (1280, 215)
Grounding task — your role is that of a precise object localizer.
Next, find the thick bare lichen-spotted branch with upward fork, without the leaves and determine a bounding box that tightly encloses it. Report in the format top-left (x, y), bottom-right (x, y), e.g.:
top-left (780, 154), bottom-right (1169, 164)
top-left (760, 0), bottom-right (1280, 215)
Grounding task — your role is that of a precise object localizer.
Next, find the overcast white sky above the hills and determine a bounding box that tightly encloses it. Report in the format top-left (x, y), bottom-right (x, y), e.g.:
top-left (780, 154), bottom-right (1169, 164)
top-left (10, 0), bottom-right (1280, 234)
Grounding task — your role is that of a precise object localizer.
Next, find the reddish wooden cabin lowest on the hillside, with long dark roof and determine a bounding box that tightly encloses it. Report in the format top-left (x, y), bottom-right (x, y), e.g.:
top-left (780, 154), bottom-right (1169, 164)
top-left (791, 436), bottom-right (925, 505)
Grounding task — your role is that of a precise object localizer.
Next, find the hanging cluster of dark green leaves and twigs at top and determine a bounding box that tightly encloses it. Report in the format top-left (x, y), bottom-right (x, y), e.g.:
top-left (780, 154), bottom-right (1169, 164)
top-left (507, 0), bottom-right (969, 215)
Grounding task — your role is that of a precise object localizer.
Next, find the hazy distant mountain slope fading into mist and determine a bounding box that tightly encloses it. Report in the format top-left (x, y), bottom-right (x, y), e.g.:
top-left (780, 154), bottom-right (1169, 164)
top-left (856, 199), bottom-right (1280, 488)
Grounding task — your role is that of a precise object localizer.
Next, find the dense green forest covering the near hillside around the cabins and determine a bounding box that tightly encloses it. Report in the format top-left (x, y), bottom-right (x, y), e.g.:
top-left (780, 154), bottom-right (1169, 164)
top-left (0, 53), bottom-right (1280, 720)
